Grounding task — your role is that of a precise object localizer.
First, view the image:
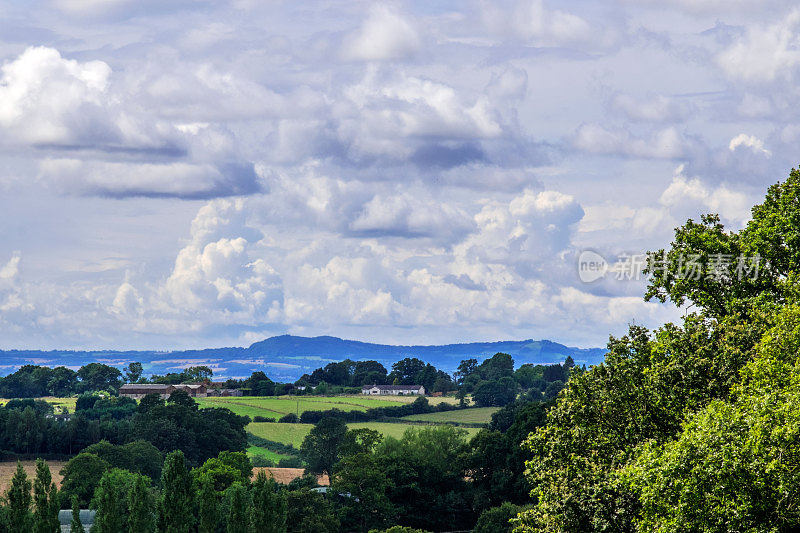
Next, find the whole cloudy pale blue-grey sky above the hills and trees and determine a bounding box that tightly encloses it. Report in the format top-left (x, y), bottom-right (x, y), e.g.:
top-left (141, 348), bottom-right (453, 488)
top-left (0, 0), bottom-right (800, 349)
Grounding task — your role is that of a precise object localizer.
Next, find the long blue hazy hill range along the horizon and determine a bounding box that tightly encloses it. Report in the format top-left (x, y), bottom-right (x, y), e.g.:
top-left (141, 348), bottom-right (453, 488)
top-left (0, 335), bottom-right (606, 381)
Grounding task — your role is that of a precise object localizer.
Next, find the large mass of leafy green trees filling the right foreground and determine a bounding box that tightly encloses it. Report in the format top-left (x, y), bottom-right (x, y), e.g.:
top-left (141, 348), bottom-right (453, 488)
top-left (517, 170), bottom-right (800, 532)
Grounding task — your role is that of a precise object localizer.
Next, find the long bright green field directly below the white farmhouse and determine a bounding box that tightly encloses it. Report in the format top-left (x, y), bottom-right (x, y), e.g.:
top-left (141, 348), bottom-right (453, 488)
top-left (196, 395), bottom-right (456, 420)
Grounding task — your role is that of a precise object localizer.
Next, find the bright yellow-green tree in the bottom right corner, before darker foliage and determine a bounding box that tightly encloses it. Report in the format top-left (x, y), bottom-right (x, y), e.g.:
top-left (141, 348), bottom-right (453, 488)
top-left (621, 305), bottom-right (800, 533)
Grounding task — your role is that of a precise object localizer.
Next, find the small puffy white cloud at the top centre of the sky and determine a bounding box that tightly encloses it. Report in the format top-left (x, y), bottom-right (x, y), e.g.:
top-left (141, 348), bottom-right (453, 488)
top-left (343, 5), bottom-right (421, 61)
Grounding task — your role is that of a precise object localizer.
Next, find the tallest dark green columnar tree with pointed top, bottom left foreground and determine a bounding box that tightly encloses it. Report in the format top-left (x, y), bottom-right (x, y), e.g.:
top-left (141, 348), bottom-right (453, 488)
top-left (158, 450), bottom-right (194, 533)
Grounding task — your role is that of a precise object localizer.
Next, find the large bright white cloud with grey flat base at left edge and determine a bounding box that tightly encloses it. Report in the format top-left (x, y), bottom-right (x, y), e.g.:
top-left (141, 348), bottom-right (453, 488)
top-left (0, 47), bottom-right (261, 198)
